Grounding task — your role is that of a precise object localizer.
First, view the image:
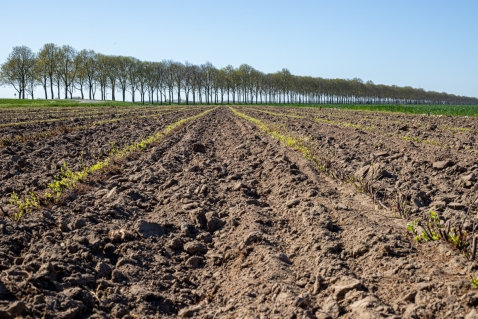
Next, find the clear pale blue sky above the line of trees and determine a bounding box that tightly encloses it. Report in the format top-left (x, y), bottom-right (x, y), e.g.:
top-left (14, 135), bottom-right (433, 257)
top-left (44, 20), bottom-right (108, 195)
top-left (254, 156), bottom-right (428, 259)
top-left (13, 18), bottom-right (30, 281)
top-left (0, 0), bottom-right (478, 97)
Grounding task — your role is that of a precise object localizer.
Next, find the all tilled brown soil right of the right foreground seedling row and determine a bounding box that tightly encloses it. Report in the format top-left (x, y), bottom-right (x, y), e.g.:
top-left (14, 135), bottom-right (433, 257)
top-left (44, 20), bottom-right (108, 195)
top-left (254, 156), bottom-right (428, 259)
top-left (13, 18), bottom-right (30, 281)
top-left (242, 109), bottom-right (478, 218)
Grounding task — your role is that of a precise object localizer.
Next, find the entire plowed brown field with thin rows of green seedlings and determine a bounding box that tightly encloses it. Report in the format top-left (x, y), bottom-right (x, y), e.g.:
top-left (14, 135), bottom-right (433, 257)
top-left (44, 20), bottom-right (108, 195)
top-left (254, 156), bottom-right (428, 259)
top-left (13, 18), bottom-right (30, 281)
top-left (0, 106), bottom-right (478, 319)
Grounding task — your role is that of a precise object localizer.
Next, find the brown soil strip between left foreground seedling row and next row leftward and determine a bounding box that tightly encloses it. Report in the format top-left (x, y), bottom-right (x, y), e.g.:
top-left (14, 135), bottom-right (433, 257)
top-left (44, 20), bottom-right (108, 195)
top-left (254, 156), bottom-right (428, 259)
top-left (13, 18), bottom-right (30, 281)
top-left (0, 109), bottom-right (206, 210)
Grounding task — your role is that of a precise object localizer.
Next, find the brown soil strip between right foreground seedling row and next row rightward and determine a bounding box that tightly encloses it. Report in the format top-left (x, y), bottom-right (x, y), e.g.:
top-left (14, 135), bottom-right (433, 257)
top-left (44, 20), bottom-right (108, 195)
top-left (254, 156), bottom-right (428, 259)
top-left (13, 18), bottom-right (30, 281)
top-left (243, 109), bottom-right (478, 215)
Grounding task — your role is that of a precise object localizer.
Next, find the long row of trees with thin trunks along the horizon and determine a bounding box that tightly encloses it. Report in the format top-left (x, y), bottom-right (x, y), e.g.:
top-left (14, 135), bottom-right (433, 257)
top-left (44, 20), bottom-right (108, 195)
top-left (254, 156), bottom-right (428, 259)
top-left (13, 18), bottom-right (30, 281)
top-left (0, 43), bottom-right (478, 104)
